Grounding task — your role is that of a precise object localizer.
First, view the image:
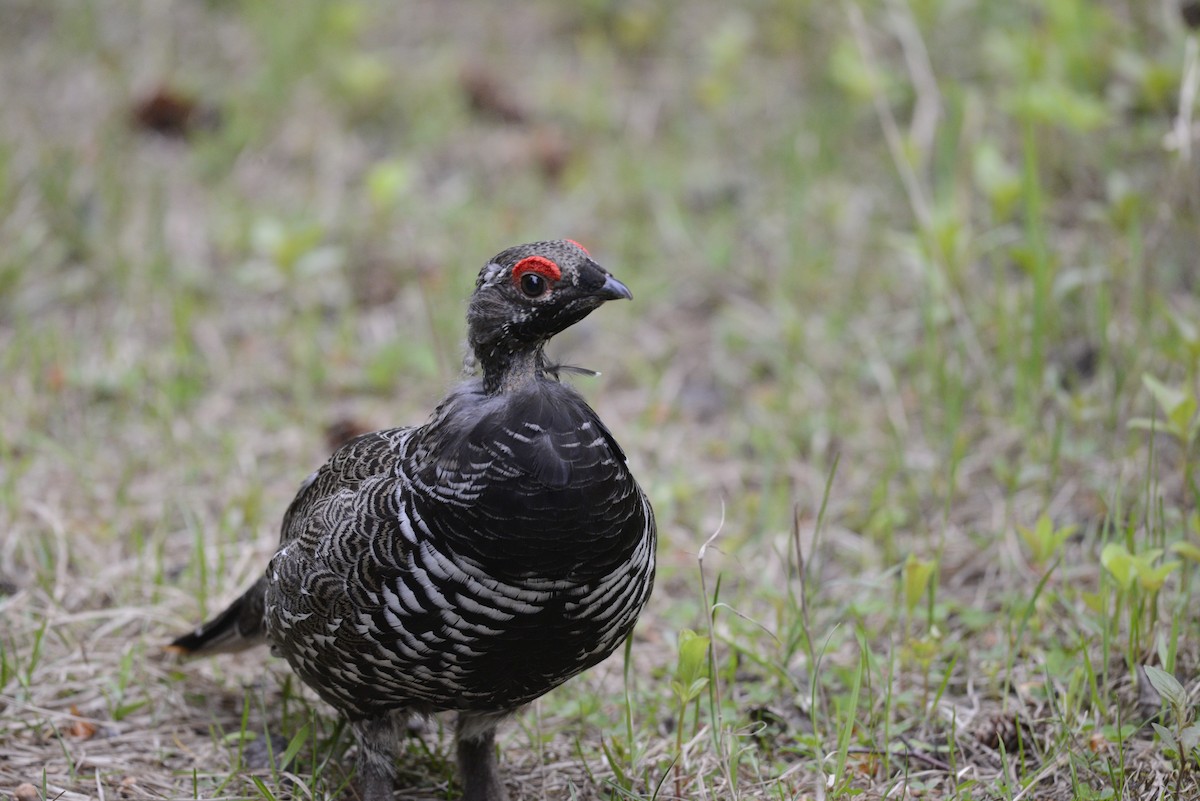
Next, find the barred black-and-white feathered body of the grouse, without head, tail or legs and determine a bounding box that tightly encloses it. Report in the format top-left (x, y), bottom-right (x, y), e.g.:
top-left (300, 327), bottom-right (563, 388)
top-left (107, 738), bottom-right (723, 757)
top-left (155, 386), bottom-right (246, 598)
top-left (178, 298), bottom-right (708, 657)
top-left (265, 381), bottom-right (654, 717)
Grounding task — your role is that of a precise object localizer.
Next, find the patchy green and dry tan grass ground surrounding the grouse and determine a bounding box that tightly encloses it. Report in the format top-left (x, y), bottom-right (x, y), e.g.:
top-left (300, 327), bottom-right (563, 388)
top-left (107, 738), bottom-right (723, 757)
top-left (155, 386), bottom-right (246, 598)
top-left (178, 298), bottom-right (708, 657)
top-left (0, 0), bottom-right (1200, 801)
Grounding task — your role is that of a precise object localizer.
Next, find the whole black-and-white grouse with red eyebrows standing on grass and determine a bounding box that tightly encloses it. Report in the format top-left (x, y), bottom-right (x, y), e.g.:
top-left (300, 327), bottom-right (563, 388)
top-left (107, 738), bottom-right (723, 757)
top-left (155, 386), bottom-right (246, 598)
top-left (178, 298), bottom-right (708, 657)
top-left (167, 240), bottom-right (656, 801)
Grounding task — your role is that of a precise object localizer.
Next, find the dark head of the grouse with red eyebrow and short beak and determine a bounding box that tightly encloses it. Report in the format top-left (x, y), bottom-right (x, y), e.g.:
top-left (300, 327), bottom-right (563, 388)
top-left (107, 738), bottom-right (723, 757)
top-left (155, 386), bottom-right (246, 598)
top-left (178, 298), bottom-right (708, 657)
top-left (467, 240), bottom-right (632, 388)
